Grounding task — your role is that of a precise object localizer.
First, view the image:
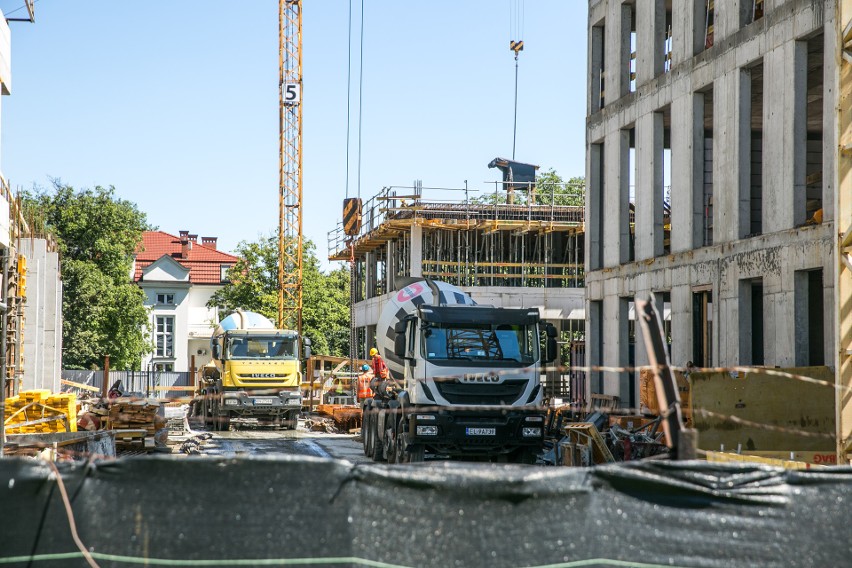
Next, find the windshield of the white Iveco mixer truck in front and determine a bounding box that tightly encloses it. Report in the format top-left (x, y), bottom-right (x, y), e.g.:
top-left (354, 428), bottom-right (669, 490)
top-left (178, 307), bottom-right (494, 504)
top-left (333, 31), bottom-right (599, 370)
top-left (423, 324), bottom-right (538, 364)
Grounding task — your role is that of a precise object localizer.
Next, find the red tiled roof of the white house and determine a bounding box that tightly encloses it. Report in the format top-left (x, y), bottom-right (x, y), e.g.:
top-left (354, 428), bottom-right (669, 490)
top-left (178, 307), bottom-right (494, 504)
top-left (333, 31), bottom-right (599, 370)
top-left (133, 231), bottom-right (239, 284)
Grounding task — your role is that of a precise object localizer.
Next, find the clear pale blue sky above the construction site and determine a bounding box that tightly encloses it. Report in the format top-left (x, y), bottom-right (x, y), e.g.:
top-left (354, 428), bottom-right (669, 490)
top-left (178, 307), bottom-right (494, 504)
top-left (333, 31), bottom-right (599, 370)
top-left (0, 0), bottom-right (587, 264)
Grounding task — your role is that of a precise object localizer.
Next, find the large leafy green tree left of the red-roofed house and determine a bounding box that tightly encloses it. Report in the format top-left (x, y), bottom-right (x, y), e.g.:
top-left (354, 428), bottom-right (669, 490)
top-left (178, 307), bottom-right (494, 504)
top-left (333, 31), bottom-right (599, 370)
top-left (22, 180), bottom-right (150, 369)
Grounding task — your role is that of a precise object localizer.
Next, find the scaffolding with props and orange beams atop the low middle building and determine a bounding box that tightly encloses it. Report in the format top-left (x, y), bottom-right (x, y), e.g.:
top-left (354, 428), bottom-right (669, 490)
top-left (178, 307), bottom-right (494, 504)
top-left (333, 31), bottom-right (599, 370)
top-left (328, 182), bottom-right (584, 301)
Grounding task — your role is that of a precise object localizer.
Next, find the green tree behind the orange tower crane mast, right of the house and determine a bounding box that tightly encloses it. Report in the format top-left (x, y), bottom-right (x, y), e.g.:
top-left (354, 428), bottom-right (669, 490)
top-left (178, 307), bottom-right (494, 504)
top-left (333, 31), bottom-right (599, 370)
top-left (207, 235), bottom-right (349, 356)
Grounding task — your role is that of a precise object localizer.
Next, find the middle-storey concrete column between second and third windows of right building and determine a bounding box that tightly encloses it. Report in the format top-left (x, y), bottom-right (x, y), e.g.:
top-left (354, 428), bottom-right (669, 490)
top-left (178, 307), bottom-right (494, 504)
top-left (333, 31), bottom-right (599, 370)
top-left (635, 112), bottom-right (663, 261)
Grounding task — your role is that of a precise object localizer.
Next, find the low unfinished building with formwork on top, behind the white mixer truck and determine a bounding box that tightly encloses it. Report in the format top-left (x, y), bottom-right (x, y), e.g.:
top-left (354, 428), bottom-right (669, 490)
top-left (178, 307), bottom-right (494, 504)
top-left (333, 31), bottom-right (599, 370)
top-left (328, 178), bottom-right (585, 396)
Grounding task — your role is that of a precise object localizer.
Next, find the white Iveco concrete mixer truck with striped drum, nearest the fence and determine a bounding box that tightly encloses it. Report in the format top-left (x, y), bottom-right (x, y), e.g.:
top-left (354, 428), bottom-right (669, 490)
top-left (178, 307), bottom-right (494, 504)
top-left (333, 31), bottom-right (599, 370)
top-left (362, 279), bottom-right (556, 463)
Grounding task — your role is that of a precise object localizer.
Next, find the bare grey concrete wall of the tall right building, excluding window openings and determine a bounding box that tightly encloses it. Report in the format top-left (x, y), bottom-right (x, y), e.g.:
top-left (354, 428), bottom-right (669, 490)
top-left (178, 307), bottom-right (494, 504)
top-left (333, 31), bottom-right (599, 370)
top-left (586, 0), bottom-right (845, 404)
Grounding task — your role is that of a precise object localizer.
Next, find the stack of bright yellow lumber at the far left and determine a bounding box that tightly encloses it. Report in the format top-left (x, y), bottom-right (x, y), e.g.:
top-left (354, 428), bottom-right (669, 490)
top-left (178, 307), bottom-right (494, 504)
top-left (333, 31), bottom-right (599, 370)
top-left (4, 389), bottom-right (77, 434)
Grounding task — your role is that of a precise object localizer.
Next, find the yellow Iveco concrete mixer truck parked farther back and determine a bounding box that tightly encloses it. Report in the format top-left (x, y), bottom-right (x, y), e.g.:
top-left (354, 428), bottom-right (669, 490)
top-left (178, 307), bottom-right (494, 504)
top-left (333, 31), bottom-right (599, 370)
top-left (192, 310), bottom-right (310, 430)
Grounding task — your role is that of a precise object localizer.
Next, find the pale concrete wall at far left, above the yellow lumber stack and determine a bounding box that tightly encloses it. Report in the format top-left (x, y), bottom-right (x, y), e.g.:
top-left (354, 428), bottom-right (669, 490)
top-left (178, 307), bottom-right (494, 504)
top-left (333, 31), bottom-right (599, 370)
top-left (19, 239), bottom-right (62, 392)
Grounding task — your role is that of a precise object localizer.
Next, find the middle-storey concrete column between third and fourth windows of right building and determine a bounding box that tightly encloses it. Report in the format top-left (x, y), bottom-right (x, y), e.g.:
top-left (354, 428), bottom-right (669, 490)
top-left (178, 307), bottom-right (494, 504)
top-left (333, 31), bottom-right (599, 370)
top-left (671, 93), bottom-right (704, 253)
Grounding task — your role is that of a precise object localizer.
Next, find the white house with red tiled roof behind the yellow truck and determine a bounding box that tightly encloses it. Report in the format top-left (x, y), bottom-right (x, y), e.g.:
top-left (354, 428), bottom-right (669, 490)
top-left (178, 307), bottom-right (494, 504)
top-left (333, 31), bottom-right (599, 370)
top-left (133, 231), bottom-right (238, 371)
